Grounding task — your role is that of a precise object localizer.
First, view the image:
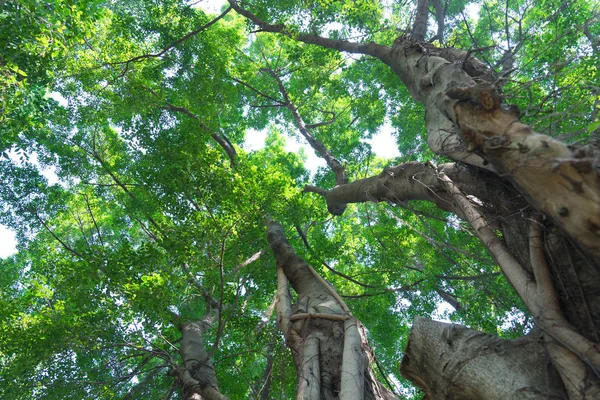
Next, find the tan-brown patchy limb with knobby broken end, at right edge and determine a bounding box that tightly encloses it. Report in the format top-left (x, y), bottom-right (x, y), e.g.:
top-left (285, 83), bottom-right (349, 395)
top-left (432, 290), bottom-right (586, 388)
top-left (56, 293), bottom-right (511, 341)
top-left (448, 85), bottom-right (600, 256)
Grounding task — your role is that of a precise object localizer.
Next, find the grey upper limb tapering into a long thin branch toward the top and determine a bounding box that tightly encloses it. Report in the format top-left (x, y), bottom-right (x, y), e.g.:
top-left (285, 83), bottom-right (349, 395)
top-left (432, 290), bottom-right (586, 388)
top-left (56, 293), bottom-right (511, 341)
top-left (229, 0), bottom-right (492, 168)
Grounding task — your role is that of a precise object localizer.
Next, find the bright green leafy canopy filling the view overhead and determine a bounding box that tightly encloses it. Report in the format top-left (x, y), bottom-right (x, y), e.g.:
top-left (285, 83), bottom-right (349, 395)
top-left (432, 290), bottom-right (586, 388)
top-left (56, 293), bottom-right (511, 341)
top-left (0, 0), bottom-right (600, 399)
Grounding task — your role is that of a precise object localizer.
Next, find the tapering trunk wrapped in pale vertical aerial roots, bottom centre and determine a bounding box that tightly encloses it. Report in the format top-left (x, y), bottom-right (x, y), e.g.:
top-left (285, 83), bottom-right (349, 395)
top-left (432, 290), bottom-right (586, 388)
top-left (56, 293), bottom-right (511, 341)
top-left (267, 222), bottom-right (396, 400)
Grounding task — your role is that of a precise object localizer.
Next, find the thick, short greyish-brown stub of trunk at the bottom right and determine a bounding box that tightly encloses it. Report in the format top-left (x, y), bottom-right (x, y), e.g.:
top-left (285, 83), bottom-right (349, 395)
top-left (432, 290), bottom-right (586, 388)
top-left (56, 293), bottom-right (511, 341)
top-left (400, 317), bottom-right (566, 400)
